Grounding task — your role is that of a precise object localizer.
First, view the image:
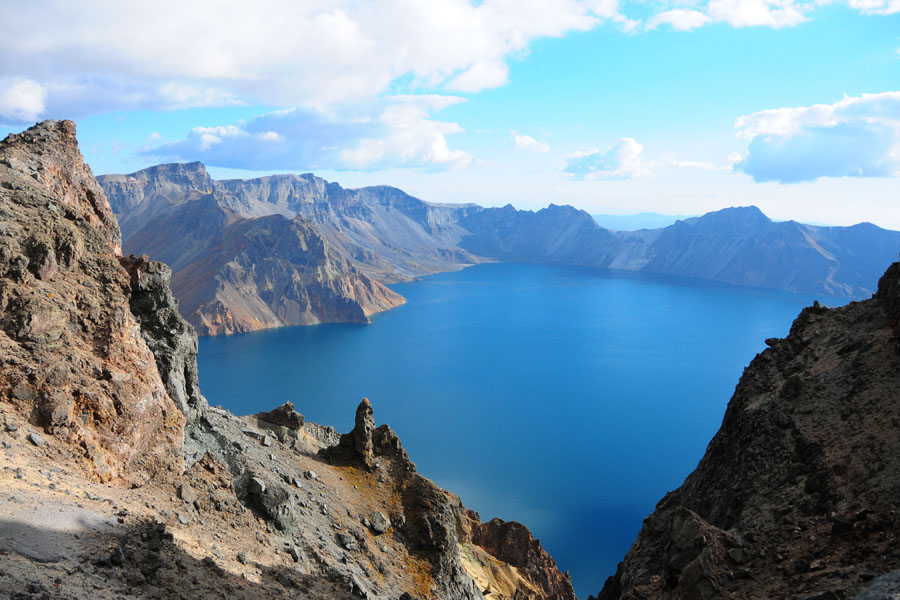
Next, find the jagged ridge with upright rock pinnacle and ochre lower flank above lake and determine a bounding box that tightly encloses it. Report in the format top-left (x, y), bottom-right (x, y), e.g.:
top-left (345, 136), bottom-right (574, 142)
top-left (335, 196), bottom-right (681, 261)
top-left (319, 399), bottom-right (575, 600)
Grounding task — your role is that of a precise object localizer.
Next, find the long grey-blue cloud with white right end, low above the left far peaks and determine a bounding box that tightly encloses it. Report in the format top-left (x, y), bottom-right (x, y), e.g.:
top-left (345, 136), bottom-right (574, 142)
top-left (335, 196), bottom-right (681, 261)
top-left (144, 96), bottom-right (472, 170)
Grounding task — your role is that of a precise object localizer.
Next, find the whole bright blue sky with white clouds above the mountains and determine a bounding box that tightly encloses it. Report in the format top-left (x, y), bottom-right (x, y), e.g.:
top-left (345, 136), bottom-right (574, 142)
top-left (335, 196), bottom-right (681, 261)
top-left (0, 0), bottom-right (900, 229)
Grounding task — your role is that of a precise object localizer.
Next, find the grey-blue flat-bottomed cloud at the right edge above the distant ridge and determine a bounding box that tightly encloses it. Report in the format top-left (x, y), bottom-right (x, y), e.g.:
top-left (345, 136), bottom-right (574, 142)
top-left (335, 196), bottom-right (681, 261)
top-left (735, 92), bottom-right (900, 183)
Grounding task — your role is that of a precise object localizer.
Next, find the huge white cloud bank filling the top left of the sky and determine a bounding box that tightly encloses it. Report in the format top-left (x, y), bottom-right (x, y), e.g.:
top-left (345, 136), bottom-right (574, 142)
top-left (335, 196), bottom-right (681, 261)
top-left (0, 0), bottom-right (628, 121)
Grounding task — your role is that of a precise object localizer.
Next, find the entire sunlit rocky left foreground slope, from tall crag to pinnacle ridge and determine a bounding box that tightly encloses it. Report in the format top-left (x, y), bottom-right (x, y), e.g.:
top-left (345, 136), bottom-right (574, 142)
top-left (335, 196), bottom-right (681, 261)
top-left (0, 121), bottom-right (575, 600)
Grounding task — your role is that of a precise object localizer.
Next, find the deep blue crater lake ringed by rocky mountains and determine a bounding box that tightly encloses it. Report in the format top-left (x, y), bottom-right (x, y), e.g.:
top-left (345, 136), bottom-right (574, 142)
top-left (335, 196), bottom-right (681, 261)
top-left (199, 264), bottom-right (844, 598)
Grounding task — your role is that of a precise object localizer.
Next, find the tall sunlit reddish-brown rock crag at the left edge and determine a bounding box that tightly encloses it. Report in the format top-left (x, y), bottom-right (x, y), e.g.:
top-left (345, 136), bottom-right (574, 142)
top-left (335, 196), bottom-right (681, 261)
top-left (0, 121), bottom-right (185, 482)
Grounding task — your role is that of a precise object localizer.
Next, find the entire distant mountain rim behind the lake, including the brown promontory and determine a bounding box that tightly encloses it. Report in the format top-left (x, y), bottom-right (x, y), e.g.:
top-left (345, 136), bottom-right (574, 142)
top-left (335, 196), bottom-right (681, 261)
top-left (98, 162), bottom-right (900, 334)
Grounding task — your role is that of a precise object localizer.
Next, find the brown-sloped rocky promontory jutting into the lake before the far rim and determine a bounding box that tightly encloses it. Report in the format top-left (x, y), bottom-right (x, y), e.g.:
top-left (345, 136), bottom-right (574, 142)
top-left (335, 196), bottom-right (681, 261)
top-left (126, 194), bottom-right (404, 335)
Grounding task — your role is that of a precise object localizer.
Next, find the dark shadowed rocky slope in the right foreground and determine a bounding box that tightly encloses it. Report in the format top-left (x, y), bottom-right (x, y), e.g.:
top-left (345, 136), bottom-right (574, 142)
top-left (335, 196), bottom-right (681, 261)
top-left (598, 263), bottom-right (900, 600)
